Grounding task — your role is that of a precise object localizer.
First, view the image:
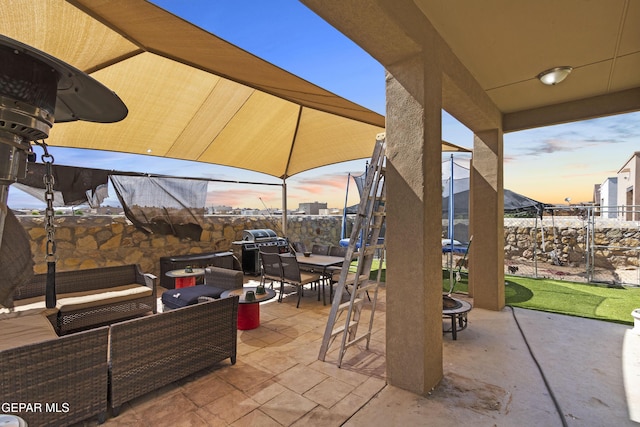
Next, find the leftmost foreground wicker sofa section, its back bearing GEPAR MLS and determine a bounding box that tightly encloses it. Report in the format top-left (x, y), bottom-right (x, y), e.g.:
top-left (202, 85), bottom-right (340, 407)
top-left (0, 326), bottom-right (109, 426)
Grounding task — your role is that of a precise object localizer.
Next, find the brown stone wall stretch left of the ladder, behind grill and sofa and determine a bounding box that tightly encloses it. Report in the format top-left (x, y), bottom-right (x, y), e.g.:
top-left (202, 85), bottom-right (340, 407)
top-left (18, 215), bottom-right (350, 276)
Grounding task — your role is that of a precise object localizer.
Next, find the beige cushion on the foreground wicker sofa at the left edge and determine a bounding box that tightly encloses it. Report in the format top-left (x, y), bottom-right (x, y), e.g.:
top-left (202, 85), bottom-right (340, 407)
top-left (0, 310), bottom-right (58, 350)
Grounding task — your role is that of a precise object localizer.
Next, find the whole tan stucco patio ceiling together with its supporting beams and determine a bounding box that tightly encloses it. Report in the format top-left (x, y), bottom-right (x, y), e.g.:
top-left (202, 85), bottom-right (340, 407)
top-left (301, 0), bottom-right (640, 131)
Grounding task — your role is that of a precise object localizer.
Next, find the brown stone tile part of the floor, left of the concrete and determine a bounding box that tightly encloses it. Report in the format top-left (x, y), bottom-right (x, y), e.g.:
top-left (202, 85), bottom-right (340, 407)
top-left (93, 278), bottom-right (385, 426)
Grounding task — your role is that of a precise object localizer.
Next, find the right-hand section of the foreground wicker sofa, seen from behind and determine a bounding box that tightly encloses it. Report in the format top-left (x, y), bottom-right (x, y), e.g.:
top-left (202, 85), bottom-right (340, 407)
top-left (109, 296), bottom-right (239, 416)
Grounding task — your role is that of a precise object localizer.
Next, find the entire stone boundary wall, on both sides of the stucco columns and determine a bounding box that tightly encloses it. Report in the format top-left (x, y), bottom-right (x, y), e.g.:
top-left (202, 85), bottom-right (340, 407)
top-left (18, 215), bottom-right (640, 276)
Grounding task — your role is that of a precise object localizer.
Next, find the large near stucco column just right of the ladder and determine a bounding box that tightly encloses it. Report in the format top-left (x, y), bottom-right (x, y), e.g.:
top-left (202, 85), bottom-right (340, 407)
top-left (385, 58), bottom-right (443, 395)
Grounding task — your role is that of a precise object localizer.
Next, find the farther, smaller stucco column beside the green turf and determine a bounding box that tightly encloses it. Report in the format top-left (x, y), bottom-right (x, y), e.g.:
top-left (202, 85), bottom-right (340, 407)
top-left (469, 129), bottom-right (505, 310)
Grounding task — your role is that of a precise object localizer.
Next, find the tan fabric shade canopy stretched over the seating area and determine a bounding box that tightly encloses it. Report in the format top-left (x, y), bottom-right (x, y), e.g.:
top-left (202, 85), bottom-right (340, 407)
top-left (0, 0), bottom-right (458, 178)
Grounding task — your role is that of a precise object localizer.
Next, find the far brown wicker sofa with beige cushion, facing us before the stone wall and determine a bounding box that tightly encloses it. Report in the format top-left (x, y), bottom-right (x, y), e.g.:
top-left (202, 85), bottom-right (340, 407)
top-left (13, 264), bottom-right (157, 335)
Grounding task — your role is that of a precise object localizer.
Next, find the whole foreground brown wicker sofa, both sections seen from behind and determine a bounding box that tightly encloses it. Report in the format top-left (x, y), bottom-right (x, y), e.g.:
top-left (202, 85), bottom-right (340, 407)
top-left (0, 297), bottom-right (238, 426)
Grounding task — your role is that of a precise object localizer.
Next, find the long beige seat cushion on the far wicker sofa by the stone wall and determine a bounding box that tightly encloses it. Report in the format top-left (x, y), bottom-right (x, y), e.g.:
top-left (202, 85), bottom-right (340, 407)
top-left (9, 283), bottom-right (153, 313)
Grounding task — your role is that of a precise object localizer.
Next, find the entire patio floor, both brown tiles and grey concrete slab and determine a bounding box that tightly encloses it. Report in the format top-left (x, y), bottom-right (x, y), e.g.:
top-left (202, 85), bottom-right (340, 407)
top-left (72, 277), bottom-right (640, 426)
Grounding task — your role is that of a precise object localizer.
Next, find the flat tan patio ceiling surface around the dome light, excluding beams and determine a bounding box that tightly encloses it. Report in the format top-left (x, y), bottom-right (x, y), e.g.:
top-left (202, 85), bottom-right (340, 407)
top-left (415, 0), bottom-right (640, 113)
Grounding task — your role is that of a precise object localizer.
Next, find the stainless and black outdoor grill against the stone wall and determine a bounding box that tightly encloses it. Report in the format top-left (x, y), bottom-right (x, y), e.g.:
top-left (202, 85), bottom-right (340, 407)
top-left (232, 228), bottom-right (289, 276)
